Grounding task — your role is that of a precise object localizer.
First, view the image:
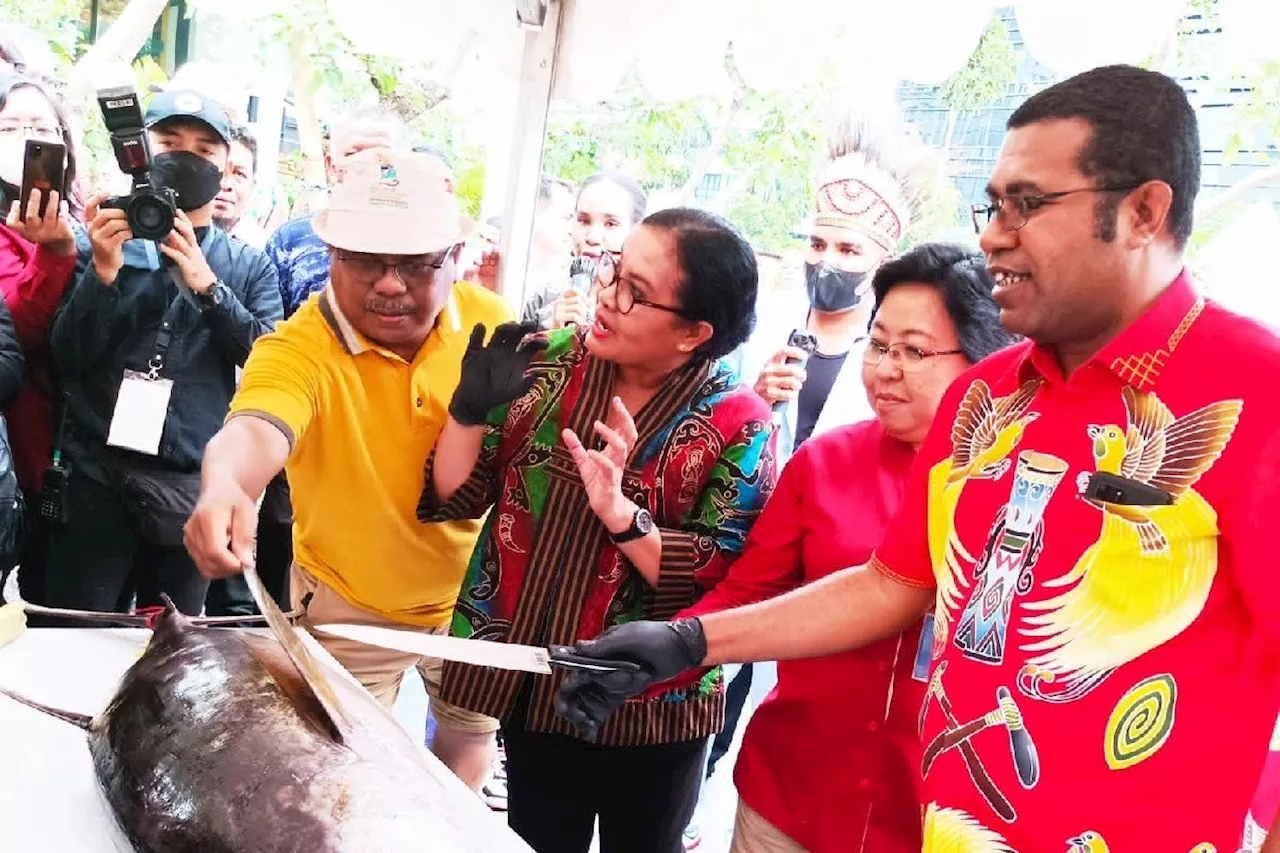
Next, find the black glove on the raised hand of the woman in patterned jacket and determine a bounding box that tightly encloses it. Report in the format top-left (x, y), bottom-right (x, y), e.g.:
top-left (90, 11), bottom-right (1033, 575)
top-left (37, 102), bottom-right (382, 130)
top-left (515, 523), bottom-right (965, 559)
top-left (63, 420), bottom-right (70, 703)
top-left (449, 323), bottom-right (547, 427)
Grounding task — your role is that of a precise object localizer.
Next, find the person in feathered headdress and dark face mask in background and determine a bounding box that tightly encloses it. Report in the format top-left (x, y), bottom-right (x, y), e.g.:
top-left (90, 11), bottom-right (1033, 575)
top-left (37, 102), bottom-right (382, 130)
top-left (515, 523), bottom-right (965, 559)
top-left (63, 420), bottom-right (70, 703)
top-left (742, 117), bottom-right (931, 460)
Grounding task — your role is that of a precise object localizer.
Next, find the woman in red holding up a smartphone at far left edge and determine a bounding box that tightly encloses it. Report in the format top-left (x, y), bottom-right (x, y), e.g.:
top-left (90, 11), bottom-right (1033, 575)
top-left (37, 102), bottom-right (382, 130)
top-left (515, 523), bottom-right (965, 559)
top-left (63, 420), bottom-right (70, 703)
top-left (0, 76), bottom-right (83, 603)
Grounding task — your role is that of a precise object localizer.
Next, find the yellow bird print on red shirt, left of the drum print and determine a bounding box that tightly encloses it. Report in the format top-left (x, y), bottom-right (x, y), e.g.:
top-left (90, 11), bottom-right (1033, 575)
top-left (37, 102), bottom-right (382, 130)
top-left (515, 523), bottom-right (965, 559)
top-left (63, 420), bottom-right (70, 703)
top-left (929, 379), bottom-right (1041, 640)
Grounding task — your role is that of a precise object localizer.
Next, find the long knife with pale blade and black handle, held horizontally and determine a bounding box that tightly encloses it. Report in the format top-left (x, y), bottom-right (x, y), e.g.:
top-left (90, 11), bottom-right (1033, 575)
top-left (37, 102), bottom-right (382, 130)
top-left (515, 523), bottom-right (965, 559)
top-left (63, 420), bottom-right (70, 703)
top-left (315, 622), bottom-right (640, 675)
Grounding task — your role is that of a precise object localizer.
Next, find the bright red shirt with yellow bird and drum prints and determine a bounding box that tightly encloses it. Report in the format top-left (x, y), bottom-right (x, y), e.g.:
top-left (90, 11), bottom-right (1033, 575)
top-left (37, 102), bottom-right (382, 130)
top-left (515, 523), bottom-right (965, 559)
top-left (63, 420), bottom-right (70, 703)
top-left (872, 273), bottom-right (1280, 853)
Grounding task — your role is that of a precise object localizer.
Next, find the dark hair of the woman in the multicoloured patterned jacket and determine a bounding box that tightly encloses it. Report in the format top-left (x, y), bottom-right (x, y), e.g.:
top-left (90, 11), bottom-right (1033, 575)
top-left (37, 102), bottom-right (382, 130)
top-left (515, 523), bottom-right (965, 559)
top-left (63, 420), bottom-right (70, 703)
top-left (640, 207), bottom-right (759, 359)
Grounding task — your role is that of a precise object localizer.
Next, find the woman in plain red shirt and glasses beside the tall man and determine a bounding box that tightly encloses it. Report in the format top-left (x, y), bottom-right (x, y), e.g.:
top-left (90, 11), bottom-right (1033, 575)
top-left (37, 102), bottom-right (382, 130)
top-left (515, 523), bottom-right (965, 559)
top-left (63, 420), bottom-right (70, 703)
top-left (682, 243), bottom-right (1012, 853)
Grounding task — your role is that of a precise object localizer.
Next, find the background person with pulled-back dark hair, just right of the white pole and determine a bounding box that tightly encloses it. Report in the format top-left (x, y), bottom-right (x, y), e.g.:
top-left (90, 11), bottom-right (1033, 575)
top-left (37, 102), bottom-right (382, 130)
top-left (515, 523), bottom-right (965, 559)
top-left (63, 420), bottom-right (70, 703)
top-left (521, 172), bottom-right (648, 330)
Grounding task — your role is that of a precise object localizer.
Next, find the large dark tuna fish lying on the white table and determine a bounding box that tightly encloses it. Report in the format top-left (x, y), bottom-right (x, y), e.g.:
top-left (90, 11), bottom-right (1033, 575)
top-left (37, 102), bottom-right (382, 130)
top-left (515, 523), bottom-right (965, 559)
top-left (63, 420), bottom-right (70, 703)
top-left (0, 596), bottom-right (527, 853)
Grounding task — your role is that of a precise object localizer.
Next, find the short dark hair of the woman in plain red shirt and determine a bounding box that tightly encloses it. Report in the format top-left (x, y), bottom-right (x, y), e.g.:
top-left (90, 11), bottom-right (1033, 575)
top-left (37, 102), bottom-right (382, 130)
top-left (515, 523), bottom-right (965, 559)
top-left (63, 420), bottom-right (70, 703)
top-left (872, 243), bottom-right (1018, 364)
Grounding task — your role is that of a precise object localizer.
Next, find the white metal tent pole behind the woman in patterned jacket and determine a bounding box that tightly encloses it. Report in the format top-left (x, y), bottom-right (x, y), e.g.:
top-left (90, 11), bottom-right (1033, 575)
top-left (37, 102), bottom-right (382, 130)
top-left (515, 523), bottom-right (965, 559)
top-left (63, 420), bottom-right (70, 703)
top-left (499, 0), bottom-right (573, 306)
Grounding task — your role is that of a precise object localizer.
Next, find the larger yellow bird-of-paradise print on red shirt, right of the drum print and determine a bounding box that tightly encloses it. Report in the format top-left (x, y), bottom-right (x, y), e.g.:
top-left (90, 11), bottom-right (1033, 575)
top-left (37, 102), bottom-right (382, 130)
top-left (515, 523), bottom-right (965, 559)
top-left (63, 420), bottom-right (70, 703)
top-left (1019, 388), bottom-right (1243, 702)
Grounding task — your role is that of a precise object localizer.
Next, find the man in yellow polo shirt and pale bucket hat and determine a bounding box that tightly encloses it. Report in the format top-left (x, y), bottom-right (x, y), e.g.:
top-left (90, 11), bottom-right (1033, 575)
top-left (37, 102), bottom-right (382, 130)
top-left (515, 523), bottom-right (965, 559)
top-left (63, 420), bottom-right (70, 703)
top-left (186, 149), bottom-right (512, 790)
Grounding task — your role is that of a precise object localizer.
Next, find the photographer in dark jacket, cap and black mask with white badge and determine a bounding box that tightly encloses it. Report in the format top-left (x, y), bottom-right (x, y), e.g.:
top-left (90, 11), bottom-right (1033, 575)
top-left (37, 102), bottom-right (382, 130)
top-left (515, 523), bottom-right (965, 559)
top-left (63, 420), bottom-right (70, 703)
top-left (45, 91), bottom-right (282, 613)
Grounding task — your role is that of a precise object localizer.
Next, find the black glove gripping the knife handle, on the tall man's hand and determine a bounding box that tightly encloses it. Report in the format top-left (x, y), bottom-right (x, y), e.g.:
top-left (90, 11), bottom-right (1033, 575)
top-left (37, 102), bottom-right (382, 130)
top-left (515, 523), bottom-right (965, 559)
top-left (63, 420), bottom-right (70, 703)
top-left (556, 619), bottom-right (707, 740)
